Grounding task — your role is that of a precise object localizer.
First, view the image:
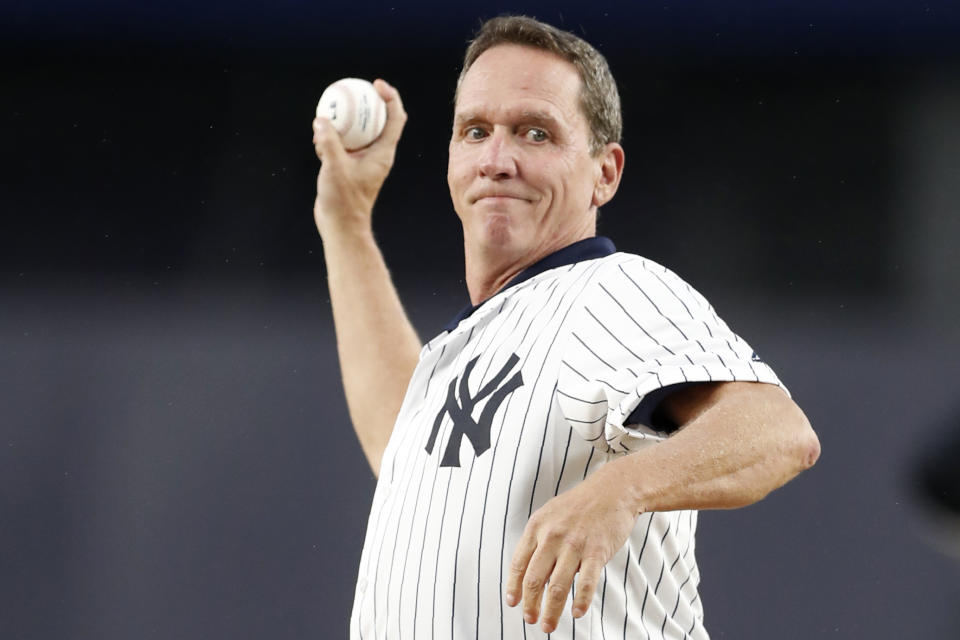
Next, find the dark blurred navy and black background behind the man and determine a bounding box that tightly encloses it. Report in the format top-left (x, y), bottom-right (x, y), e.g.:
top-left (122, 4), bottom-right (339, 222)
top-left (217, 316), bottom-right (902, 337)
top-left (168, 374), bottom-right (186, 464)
top-left (0, 0), bottom-right (960, 640)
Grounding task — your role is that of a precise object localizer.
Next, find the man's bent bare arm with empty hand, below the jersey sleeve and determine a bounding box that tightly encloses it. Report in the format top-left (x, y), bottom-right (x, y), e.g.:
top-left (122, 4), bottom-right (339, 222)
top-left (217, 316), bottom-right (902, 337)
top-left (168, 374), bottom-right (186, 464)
top-left (505, 382), bottom-right (820, 633)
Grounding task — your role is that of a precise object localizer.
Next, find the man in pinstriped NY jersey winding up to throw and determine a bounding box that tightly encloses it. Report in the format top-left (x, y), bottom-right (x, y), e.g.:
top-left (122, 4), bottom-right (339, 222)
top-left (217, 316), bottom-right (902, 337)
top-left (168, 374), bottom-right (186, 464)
top-left (314, 17), bottom-right (819, 638)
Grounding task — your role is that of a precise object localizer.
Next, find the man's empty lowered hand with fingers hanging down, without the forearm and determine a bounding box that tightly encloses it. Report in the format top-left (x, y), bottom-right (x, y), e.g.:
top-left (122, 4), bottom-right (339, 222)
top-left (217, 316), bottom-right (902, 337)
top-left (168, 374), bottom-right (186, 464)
top-left (505, 468), bottom-right (638, 633)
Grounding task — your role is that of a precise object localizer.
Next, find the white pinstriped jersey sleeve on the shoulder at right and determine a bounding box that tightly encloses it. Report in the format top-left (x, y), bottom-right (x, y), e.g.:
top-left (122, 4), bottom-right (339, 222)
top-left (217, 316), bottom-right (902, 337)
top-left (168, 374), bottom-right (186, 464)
top-left (557, 256), bottom-right (783, 453)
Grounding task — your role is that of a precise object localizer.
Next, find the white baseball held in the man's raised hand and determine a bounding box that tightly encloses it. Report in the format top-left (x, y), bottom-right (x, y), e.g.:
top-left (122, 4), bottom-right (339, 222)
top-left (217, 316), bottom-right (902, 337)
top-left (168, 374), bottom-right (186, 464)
top-left (317, 78), bottom-right (387, 151)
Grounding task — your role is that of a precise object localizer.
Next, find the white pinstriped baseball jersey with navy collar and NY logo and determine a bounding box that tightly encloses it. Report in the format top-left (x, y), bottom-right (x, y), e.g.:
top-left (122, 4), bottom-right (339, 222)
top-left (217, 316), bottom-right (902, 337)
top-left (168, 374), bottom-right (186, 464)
top-left (350, 238), bottom-right (779, 640)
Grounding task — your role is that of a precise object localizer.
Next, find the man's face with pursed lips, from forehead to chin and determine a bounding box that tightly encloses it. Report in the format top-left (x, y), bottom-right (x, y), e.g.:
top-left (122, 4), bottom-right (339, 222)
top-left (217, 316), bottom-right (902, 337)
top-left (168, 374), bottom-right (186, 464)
top-left (447, 44), bottom-right (612, 262)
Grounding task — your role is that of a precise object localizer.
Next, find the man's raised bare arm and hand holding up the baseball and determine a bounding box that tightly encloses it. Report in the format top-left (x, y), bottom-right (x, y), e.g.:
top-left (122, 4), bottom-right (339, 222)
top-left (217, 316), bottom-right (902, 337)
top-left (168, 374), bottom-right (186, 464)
top-left (313, 80), bottom-right (420, 473)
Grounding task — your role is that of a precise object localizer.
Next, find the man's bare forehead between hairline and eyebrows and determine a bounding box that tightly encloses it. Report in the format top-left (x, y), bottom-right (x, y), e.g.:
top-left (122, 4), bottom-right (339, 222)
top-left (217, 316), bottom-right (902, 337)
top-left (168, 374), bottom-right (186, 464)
top-left (454, 44), bottom-right (585, 124)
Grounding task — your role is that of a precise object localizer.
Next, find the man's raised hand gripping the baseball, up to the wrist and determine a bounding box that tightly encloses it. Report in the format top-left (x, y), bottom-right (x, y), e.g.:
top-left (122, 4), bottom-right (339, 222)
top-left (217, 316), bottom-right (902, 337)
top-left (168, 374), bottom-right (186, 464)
top-left (313, 80), bottom-right (407, 237)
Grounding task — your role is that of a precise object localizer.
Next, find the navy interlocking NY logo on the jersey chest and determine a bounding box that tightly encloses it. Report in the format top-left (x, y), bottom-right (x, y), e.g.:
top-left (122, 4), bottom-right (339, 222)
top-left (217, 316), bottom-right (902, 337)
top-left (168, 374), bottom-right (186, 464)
top-left (425, 354), bottom-right (523, 467)
